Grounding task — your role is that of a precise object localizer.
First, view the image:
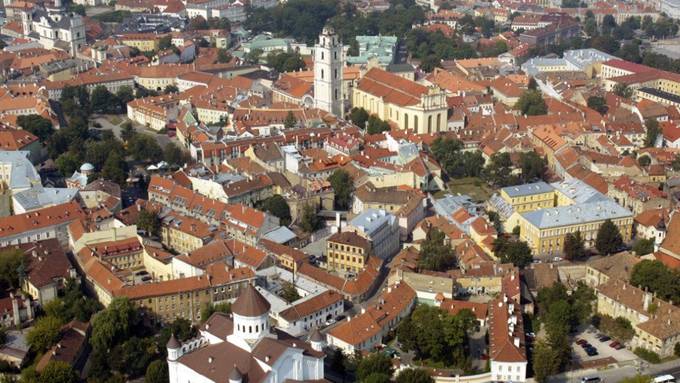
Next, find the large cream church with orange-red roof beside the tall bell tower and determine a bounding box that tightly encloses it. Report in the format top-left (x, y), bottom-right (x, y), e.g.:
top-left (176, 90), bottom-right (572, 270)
top-left (352, 68), bottom-right (448, 133)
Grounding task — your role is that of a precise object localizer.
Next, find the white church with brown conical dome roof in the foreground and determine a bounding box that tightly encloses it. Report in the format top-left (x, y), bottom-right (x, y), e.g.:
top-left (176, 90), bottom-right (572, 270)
top-left (167, 285), bottom-right (324, 383)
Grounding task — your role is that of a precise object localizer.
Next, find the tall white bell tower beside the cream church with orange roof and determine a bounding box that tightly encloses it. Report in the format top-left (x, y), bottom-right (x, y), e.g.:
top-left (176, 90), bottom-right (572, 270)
top-left (314, 27), bottom-right (345, 117)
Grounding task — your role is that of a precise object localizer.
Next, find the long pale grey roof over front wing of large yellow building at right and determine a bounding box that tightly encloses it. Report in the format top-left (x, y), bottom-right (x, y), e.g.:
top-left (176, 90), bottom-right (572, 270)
top-left (522, 199), bottom-right (633, 229)
